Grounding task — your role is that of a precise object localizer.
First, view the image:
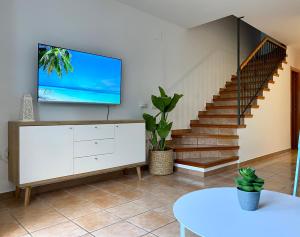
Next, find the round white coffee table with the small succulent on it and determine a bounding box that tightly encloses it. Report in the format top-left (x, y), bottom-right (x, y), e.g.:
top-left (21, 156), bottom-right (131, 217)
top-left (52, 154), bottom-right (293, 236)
top-left (173, 188), bottom-right (300, 237)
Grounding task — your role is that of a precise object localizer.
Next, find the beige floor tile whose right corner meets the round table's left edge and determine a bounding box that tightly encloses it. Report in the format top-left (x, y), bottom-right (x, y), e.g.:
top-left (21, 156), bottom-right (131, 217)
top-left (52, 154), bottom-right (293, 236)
top-left (127, 211), bottom-right (174, 232)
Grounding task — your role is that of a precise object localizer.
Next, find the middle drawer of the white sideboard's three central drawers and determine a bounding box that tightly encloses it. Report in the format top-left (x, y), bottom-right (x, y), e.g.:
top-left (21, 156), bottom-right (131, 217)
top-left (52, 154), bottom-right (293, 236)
top-left (74, 139), bottom-right (115, 157)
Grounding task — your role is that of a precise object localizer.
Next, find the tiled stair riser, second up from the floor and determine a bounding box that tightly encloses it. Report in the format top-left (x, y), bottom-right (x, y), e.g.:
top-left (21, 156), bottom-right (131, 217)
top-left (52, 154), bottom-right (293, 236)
top-left (175, 150), bottom-right (238, 160)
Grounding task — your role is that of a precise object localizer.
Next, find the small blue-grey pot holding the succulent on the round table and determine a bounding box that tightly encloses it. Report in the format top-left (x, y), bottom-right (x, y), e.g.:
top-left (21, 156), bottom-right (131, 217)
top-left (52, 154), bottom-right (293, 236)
top-left (237, 189), bottom-right (261, 211)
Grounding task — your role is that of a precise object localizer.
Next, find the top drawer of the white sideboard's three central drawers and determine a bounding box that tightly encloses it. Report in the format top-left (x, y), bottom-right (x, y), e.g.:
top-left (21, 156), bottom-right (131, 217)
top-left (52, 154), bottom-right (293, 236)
top-left (74, 124), bottom-right (115, 141)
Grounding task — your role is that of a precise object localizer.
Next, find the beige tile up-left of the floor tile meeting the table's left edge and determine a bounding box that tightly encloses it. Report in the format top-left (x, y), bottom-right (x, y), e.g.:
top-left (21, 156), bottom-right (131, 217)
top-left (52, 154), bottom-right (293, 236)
top-left (107, 203), bottom-right (149, 219)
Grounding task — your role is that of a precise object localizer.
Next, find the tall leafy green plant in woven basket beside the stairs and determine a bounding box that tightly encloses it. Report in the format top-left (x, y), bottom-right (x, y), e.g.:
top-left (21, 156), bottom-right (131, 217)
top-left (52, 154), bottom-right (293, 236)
top-left (143, 87), bottom-right (183, 175)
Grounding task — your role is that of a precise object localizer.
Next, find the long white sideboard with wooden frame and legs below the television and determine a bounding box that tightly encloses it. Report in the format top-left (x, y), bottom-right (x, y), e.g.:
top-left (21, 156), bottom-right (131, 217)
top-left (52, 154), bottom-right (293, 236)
top-left (9, 121), bottom-right (146, 204)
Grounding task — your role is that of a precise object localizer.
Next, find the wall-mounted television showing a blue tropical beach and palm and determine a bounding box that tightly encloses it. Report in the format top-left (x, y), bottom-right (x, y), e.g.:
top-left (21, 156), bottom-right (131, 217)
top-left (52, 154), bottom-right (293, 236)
top-left (38, 44), bottom-right (122, 104)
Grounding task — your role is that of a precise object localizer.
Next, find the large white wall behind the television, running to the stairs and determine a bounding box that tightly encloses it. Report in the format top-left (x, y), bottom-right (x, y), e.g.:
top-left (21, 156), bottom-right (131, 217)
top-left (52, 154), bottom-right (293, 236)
top-left (0, 0), bottom-right (257, 193)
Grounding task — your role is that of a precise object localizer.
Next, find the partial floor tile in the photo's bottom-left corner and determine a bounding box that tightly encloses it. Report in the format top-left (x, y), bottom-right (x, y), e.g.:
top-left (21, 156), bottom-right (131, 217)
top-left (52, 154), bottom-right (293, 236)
top-left (0, 211), bottom-right (27, 237)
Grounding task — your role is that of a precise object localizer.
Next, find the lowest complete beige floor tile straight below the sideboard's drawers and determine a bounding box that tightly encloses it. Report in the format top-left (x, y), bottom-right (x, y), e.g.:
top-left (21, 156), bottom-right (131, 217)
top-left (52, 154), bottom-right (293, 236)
top-left (74, 211), bottom-right (121, 232)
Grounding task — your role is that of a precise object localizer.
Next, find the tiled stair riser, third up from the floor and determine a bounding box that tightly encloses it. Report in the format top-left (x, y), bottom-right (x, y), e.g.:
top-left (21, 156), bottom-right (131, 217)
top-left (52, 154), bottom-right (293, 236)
top-left (173, 137), bottom-right (238, 146)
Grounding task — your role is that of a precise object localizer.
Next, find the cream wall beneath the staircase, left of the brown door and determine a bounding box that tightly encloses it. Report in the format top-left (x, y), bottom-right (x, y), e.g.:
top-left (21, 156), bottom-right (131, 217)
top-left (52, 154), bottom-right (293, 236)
top-left (238, 48), bottom-right (300, 162)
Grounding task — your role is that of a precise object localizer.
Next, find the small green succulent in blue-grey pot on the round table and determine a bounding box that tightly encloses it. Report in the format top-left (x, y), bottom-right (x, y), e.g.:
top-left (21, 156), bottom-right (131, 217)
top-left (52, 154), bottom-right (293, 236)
top-left (235, 167), bottom-right (264, 211)
